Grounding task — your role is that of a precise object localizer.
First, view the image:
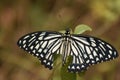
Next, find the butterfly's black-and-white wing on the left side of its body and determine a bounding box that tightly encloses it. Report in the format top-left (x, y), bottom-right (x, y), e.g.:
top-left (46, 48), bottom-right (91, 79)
top-left (17, 31), bottom-right (62, 69)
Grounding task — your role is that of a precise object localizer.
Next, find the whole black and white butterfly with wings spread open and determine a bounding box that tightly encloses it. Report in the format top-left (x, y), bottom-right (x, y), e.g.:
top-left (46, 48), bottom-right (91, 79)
top-left (17, 30), bottom-right (118, 72)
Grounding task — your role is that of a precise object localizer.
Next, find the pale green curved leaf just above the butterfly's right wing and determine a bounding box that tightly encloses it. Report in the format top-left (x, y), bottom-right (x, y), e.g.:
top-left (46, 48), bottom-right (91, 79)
top-left (74, 24), bottom-right (92, 34)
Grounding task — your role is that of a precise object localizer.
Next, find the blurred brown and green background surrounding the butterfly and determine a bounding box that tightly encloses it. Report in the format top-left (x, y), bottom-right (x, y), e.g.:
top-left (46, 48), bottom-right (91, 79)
top-left (0, 0), bottom-right (120, 80)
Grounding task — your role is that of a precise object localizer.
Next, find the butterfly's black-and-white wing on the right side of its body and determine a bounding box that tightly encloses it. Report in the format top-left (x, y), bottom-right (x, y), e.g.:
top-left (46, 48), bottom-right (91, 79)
top-left (68, 35), bottom-right (118, 72)
